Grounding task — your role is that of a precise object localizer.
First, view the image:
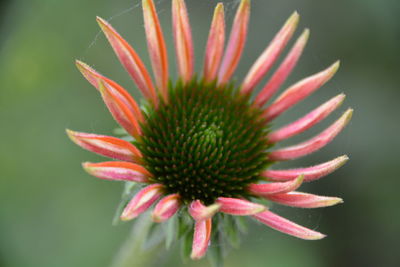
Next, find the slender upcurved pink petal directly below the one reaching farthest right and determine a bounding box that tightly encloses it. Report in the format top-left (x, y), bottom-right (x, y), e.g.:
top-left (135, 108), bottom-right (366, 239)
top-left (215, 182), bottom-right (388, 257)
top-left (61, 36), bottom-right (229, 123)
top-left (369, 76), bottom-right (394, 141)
top-left (261, 155), bottom-right (349, 182)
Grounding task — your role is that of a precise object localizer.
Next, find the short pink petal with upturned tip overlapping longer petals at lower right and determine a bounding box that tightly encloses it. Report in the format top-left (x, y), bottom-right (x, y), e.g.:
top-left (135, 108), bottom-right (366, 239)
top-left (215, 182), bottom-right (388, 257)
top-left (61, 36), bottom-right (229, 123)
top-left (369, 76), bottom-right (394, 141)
top-left (248, 175), bottom-right (304, 196)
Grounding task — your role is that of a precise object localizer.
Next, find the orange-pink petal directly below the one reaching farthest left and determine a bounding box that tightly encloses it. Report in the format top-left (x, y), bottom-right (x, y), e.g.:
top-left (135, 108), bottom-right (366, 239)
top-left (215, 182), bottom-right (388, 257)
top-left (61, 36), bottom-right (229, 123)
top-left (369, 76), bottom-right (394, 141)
top-left (82, 161), bottom-right (152, 183)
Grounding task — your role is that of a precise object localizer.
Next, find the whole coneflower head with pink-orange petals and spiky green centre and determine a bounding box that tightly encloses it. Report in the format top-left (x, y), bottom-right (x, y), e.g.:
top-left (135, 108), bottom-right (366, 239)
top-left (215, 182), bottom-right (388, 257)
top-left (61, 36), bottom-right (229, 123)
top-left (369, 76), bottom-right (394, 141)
top-left (67, 0), bottom-right (353, 259)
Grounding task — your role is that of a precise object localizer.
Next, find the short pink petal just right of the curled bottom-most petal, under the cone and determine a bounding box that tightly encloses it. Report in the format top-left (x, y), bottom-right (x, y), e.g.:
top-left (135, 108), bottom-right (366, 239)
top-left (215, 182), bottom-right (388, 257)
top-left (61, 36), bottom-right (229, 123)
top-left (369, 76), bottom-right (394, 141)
top-left (216, 197), bottom-right (266, 216)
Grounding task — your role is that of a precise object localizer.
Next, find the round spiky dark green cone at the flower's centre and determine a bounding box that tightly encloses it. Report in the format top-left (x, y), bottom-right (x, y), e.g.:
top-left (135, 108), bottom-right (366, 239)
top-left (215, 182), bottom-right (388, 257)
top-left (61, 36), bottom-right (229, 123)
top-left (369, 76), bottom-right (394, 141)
top-left (136, 80), bottom-right (270, 204)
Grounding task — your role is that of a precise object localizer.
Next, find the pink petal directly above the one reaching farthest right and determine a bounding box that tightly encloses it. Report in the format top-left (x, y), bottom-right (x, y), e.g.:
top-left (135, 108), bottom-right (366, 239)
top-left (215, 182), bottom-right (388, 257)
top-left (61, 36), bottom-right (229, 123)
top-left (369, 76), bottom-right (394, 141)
top-left (268, 94), bottom-right (345, 143)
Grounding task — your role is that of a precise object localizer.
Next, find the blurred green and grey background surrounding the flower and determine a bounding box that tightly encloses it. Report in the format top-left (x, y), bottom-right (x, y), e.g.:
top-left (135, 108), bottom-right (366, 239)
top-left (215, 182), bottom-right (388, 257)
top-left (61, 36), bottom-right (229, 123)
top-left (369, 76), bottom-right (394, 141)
top-left (0, 0), bottom-right (400, 267)
